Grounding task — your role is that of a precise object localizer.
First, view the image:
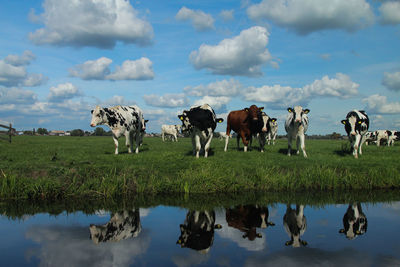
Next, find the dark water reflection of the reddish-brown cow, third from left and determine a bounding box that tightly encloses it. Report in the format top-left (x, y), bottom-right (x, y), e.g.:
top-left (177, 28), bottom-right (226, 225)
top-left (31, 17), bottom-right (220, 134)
top-left (226, 205), bottom-right (275, 241)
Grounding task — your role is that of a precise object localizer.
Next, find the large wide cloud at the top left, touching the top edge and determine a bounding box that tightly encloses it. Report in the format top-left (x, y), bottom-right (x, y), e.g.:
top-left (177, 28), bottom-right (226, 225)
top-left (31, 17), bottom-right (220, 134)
top-left (29, 0), bottom-right (153, 49)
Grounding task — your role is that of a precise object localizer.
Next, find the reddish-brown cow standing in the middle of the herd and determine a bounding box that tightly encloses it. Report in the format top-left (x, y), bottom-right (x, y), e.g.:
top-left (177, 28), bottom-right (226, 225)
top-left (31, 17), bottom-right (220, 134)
top-left (224, 105), bottom-right (267, 152)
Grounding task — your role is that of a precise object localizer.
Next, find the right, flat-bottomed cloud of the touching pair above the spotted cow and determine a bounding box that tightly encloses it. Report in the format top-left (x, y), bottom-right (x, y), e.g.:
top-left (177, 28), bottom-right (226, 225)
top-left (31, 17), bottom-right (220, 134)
top-left (105, 57), bottom-right (154, 80)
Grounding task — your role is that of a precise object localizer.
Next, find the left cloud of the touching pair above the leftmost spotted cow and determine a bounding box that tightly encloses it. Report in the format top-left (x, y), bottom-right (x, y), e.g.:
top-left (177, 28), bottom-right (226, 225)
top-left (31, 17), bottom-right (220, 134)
top-left (69, 57), bottom-right (112, 80)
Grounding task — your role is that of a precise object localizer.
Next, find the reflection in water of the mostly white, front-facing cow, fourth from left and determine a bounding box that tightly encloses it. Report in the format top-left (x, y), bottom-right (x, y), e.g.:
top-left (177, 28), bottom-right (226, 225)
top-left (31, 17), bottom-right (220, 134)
top-left (283, 205), bottom-right (307, 247)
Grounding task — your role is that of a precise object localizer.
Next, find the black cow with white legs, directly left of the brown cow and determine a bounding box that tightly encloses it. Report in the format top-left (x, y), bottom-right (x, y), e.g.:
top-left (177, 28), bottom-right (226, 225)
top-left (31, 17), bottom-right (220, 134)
top-left (178, 104), bottom-right (224, 158)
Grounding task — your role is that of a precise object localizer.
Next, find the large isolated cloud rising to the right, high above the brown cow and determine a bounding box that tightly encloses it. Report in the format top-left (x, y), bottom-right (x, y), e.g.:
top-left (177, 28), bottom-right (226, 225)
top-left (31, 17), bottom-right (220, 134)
top-left (189, 26), bottom-right (271, 76)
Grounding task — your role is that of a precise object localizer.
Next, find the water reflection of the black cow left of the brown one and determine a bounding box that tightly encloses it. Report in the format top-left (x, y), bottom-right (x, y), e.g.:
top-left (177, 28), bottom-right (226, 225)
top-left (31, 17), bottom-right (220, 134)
top-left (176, 211), bottom-right (222, 253)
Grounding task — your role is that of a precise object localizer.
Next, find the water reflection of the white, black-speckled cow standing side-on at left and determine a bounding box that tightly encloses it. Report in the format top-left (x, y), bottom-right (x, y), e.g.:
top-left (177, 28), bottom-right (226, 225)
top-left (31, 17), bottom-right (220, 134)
top-left (90, 209), bottom-right (142, 244)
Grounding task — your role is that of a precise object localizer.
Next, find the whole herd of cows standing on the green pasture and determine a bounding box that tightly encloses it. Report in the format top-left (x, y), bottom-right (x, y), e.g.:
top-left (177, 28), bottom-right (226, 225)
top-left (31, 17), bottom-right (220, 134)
top-left (90, 104), bottom-right (400, 158)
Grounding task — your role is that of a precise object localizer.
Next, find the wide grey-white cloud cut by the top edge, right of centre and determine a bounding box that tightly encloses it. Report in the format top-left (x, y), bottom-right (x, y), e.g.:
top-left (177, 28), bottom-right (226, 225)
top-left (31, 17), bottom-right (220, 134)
top-left (247, 0), bottom-right (374, 35)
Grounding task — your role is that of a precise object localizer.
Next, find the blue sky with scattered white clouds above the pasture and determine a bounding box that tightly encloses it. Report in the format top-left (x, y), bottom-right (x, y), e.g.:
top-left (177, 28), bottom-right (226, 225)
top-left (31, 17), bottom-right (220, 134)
top-left (0, 0), bottom-right (400, 134)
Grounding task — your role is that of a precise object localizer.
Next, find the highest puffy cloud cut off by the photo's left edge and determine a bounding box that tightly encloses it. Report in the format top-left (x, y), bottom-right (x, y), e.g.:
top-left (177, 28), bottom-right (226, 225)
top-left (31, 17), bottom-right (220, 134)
top-left (0, 51), bottom-right (47, 87)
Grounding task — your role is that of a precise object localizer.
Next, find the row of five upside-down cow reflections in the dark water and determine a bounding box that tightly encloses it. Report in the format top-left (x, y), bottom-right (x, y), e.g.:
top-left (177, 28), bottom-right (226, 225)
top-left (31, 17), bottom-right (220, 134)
top-left (90, 203), bottom-right (368, 250)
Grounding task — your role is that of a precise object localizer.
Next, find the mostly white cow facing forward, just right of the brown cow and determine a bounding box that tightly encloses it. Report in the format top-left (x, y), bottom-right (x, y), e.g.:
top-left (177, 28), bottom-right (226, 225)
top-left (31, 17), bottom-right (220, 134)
top-left (285, 106), bottom-right (310, 158)
